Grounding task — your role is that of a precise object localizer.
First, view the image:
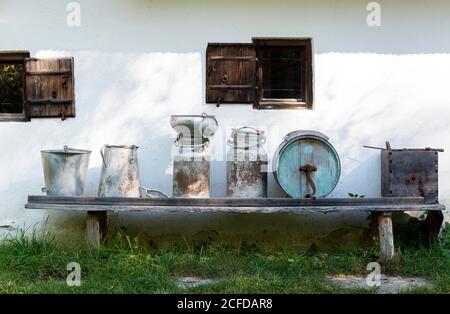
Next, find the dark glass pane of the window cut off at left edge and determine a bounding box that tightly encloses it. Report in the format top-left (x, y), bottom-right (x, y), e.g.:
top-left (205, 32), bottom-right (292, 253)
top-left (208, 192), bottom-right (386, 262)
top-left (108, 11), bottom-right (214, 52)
top-left (0, 64), bottom-right (23, 113)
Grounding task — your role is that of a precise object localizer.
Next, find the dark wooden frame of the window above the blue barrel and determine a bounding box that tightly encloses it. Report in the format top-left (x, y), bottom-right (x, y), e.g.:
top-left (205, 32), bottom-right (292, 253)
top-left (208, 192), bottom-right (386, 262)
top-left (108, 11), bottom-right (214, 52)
top-left (252, 37), bottom-right (314, 110)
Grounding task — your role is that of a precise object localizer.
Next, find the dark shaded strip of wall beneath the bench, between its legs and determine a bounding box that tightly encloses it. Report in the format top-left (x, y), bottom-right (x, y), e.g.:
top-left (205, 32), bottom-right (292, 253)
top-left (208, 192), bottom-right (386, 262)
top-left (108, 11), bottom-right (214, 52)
top-left (109, 213), bottom-right (372, 251)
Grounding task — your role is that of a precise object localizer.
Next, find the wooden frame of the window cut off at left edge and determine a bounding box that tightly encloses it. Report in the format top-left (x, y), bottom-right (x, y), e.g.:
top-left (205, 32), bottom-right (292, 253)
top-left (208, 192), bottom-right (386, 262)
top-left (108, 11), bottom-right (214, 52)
top-left (0, 50), bottom-right (30, 122)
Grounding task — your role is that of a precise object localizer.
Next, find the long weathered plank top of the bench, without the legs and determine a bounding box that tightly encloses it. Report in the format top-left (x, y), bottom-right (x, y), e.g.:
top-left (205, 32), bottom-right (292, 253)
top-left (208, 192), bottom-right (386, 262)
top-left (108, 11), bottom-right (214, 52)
top-left (25, 196), bottom-right (444, 212)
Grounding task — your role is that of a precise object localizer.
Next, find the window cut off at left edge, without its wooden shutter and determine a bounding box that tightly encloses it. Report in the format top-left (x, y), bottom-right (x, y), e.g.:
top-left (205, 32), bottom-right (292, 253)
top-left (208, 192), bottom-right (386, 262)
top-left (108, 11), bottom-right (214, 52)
top-left (0, 51), bottom-right (30, 121)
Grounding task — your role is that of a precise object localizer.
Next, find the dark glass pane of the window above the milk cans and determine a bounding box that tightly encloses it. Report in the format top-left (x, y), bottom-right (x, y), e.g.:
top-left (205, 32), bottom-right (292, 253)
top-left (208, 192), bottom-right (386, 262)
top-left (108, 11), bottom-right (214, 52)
top-left (262, 47), bottom-right (304, 100)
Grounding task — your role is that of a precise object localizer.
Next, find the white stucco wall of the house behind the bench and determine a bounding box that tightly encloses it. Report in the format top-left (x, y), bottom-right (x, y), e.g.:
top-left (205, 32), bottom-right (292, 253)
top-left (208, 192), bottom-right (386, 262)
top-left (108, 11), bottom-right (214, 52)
top-left (0, 0), bottom-right (450, 250)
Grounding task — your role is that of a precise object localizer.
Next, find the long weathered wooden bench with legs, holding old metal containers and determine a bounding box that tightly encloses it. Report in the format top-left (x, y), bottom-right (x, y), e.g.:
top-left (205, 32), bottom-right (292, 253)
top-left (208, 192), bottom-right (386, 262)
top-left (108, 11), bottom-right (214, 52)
top-left (25, 196), bottom-right (445, 259)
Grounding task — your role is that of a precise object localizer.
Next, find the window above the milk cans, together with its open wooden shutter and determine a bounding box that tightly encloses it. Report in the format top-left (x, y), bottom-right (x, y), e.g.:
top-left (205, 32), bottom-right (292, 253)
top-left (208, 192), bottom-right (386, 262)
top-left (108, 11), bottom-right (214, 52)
top-left (206, 38), bottom-right (313, 109)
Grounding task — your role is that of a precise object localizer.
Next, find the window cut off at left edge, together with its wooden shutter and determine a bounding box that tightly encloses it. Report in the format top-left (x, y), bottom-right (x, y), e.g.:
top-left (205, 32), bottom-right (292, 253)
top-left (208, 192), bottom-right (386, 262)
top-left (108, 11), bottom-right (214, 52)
top-left (0, 51), bottom-right (75, 122)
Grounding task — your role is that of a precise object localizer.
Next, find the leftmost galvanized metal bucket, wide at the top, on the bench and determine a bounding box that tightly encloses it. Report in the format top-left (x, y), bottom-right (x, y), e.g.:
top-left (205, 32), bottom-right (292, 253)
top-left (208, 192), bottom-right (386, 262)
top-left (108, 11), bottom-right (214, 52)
top-left (41, 146), bottom-right (91, 196)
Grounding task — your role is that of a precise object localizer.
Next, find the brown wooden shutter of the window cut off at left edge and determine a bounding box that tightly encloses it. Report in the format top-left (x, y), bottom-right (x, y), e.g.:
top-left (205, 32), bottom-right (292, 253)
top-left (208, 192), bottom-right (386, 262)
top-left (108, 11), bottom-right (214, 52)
top-left (25, 58), bottom-right (75, 120)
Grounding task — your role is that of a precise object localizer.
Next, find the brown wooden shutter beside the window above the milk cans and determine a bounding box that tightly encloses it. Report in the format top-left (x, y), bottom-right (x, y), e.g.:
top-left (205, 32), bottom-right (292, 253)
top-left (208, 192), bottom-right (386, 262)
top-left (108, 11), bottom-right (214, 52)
top-left (206, 44), bottom-right (257, 105)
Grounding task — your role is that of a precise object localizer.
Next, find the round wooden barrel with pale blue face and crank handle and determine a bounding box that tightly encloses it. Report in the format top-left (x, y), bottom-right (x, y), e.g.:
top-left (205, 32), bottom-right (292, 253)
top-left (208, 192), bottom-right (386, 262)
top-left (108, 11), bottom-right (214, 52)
top-left (273, 130), bottom-right (341, 198)
